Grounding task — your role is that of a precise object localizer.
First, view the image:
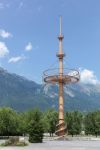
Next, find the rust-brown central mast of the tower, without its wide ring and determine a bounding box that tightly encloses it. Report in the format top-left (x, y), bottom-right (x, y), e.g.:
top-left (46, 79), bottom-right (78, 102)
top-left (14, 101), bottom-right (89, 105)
top-left (56, 17), bottom-right (66, 136)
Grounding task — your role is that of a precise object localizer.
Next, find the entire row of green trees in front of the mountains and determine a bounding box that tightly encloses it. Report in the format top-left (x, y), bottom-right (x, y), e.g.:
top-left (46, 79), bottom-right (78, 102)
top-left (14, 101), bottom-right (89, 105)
top-left (0, 107), bottom-right (100, 142)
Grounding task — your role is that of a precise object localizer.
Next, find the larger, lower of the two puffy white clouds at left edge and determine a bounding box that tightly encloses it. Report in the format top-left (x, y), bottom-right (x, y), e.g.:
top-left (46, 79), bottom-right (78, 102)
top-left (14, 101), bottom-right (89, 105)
top-left (0, 42), bottom-right (9, 57)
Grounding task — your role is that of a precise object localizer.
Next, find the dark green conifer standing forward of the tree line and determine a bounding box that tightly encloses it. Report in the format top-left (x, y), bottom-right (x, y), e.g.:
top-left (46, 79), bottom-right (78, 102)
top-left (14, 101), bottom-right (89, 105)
top-left (27, 109), bottom-right (44, 143)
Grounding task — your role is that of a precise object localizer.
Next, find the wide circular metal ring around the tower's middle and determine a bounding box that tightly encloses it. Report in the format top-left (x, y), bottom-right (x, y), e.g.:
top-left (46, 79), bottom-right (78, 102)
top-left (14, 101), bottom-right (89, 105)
top-left (43, 68), bottom-right (80, 84)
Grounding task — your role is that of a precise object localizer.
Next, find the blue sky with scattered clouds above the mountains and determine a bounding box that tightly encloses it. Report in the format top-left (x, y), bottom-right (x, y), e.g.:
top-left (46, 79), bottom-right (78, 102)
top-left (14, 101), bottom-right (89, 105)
top-left (0, 0), bottom-right (100, 84)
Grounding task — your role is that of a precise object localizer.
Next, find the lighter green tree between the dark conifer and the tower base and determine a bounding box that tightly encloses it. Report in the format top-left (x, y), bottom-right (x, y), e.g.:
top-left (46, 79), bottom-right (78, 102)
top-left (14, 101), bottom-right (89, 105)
top-left (43, 109), bottom-right (58, 136)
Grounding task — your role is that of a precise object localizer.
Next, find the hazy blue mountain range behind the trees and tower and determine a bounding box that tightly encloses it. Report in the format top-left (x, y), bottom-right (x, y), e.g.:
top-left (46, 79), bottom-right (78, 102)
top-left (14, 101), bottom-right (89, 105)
top-left (0, 68), bottom-right (100, 111)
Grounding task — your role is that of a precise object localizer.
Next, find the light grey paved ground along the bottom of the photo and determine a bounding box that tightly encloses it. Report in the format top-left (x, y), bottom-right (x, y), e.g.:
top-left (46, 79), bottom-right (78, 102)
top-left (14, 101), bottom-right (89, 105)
top-left (0, 141), bottom-right (100, 150)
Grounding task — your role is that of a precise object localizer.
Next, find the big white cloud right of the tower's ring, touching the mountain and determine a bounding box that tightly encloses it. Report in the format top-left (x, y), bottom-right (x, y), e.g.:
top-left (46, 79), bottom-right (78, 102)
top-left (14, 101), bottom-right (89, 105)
top-left (80, 69), bottom-right (99, 84)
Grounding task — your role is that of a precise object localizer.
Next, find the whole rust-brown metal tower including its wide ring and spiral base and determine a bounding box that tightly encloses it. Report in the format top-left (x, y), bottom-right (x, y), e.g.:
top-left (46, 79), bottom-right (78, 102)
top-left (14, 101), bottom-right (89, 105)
top-left (43, 17), bottom-right (80, 136)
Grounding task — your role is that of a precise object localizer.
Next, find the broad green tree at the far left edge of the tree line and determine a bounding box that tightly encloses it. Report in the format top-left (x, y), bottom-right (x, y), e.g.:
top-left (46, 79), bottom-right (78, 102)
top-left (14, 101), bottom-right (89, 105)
top-left (0, 108), bottom-right (19, 136)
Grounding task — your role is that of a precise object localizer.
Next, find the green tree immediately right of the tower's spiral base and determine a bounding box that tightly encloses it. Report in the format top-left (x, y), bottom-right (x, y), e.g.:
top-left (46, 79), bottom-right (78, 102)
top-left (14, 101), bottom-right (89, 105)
top-left (65, 111), bottom-right (82, 136)
